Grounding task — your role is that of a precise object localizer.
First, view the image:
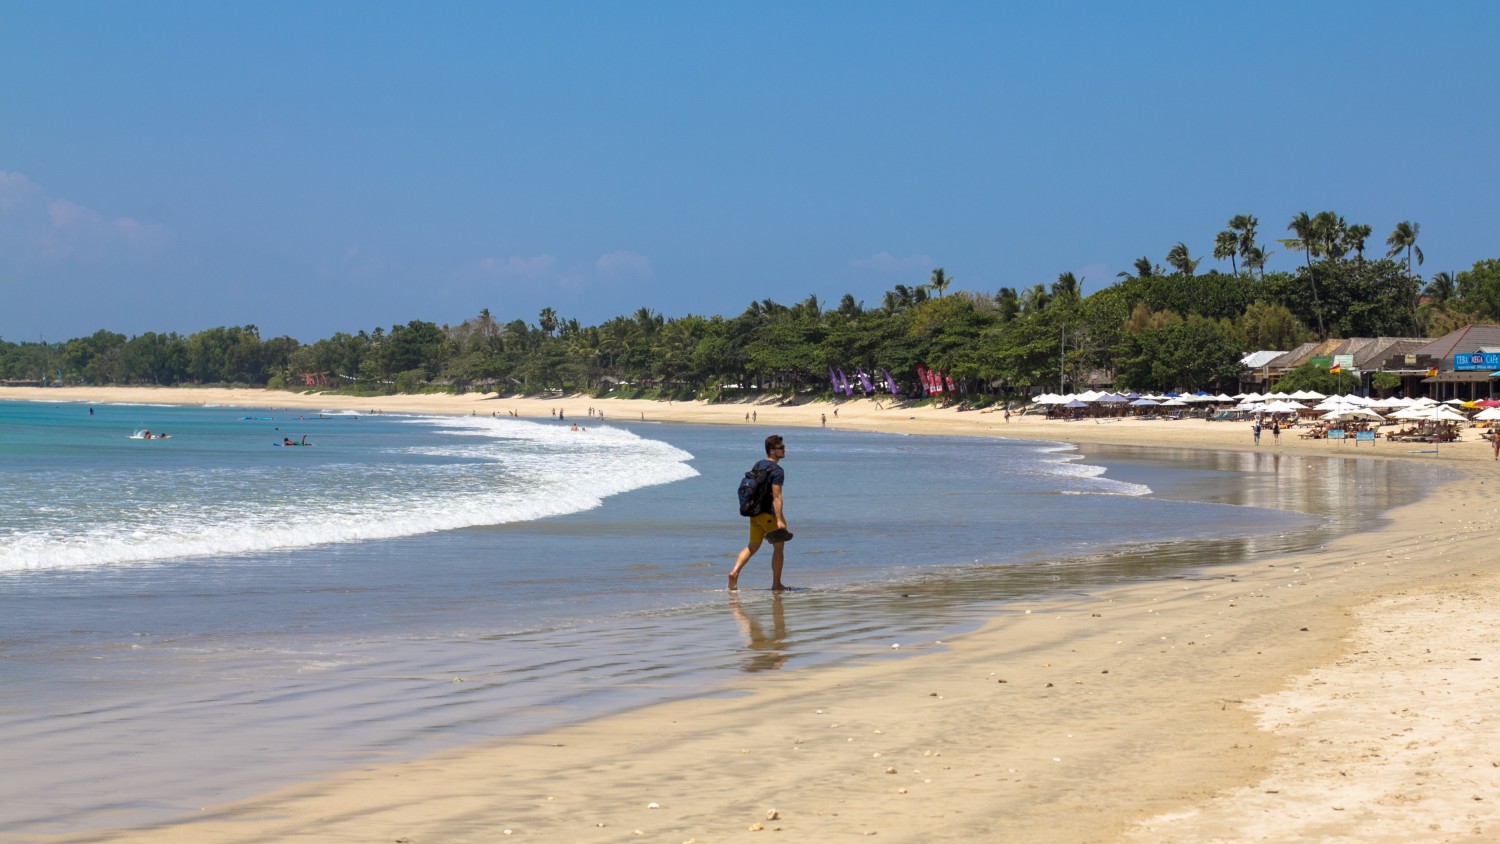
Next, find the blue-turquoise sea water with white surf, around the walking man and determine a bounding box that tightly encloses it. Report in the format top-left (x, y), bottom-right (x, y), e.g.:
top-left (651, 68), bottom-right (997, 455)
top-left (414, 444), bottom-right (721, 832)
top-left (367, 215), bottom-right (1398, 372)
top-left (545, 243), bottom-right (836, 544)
top-left (0, 402), bottom-right (1427, 835)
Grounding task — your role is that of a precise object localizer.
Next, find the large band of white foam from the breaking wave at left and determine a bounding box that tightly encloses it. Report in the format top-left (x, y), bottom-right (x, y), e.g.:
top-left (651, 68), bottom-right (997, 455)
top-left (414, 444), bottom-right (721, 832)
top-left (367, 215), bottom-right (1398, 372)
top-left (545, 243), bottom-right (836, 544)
top-left (0, 417), bottom-right (698, 571)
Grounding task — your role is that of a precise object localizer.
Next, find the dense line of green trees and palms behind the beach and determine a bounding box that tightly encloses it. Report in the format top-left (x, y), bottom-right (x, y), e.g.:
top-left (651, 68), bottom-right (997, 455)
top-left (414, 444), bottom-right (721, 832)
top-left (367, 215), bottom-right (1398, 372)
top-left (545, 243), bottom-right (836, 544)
top-left (0, 211), bottom-right (1500, 397)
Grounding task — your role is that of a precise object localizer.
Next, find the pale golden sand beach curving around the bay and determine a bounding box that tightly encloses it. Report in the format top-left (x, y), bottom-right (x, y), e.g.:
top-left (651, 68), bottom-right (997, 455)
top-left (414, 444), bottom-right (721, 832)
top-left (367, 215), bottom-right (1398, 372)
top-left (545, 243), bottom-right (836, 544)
top-left (11, 388), bottom-right (1500, 844)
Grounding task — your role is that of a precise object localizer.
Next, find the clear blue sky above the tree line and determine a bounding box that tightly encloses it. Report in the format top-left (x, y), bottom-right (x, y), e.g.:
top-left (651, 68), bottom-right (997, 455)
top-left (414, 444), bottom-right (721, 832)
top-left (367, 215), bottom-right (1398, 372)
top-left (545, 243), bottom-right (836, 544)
top-left (0, 0), bottom-right (1500, 342)
